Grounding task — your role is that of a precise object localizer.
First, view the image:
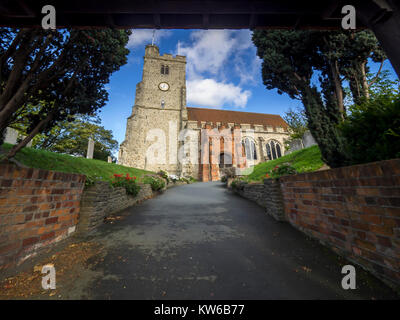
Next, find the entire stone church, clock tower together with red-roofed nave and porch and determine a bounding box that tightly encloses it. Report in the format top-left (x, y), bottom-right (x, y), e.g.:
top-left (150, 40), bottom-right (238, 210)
top-left (118, 45), bottom-right (289, 181)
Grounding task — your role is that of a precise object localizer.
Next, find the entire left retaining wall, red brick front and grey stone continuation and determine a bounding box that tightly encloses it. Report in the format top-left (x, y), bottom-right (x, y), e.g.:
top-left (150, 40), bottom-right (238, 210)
top-left (0, 164), bottom-right (193, 270)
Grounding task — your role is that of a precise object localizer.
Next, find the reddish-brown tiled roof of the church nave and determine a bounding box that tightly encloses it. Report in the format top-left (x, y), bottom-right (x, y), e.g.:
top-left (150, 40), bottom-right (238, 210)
top-left (187, 107), bottom-right (288, 129)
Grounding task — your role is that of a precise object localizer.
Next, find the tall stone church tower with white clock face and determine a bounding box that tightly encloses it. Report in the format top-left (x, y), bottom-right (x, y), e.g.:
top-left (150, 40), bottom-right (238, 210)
top-left (118, 45), bottom-right (187, 175)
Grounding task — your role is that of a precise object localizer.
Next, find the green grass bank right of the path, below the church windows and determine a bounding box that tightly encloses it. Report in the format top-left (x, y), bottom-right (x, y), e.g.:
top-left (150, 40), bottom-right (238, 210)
top-left (246, 146), bottom-right (324, 181)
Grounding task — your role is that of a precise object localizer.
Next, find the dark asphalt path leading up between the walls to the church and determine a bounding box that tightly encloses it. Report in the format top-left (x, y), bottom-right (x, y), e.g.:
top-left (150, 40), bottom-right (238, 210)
top-left (54, 182), bottom-right (396, 299)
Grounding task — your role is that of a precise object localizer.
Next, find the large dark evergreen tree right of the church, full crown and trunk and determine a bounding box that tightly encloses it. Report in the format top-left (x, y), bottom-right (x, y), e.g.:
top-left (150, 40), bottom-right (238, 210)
top-left (253, 30), bottom-right (384, 167)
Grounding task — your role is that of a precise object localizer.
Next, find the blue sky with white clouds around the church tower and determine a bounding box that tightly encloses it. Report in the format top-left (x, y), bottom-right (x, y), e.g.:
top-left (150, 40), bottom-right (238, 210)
top-left (100, 29), bottom-right (393, 152)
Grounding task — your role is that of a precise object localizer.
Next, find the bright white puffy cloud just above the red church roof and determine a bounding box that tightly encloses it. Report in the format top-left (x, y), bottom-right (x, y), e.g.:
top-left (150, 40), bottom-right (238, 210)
top-left (186, 79), bottom-right (251, 108)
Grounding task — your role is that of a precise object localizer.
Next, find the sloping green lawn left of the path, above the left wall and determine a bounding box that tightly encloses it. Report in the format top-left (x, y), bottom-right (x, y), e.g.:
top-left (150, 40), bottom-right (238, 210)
top-left (2, 143), bottom-right (152, 181)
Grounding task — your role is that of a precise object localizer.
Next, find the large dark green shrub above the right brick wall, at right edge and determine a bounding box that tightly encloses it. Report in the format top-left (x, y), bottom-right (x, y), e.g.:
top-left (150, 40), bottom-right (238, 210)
top-left (340, 95), bottom-right (400, 164)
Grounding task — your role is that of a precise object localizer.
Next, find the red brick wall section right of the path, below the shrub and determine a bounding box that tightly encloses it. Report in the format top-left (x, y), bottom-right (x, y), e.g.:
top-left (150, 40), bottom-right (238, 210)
top-left (280, 159), bottom-right (400, 286)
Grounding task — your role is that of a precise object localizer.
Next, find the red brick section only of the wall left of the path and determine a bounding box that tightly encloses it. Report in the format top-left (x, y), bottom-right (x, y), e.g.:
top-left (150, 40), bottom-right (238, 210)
top-left (0, 164), bottom-right (85, 269)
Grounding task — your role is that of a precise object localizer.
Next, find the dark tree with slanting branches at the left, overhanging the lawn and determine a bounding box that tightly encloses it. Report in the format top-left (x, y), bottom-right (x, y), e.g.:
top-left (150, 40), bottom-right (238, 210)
top-left (0, 28), bottom-right (130, 158)
